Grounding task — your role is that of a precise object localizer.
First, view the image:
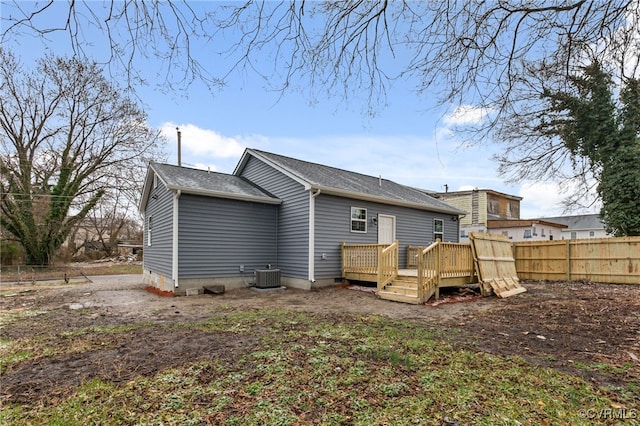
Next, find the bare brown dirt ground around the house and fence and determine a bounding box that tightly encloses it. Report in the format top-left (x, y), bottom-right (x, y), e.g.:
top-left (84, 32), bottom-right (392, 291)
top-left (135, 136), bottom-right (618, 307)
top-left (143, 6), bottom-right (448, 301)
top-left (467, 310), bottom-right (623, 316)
top-left (0, 275), bottom-right (640, 402)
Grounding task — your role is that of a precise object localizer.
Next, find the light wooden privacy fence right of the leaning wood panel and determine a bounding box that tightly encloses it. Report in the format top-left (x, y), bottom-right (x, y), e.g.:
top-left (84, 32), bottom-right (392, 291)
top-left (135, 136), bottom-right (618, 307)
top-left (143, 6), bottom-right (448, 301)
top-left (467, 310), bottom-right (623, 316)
top-left (513, 237), bottom-right (640, 284)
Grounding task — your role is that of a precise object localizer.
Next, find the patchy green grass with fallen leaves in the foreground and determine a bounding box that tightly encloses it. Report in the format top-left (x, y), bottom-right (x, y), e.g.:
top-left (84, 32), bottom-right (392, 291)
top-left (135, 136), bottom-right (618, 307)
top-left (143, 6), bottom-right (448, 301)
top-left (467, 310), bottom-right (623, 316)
top-left (0, 310), bottom-right (635, 425)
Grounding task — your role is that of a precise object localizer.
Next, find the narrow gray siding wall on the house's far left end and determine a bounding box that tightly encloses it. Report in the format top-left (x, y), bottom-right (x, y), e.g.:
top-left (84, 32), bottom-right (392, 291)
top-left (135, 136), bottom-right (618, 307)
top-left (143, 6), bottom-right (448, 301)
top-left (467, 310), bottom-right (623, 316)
top-left (143, 184), bottom-right (173, 278)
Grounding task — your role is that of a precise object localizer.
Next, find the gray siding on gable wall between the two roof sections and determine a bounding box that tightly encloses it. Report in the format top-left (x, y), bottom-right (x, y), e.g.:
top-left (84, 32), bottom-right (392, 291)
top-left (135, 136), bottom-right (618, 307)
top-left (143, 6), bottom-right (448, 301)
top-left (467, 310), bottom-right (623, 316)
top-left (242, 157), bottom-right (309, 279)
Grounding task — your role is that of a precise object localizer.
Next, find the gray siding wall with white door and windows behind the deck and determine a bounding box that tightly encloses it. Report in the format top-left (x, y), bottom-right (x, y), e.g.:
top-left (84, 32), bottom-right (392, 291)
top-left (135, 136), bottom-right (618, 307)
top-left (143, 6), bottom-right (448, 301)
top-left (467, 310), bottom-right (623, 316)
top-left (314, 194), bottom-right (459, 279)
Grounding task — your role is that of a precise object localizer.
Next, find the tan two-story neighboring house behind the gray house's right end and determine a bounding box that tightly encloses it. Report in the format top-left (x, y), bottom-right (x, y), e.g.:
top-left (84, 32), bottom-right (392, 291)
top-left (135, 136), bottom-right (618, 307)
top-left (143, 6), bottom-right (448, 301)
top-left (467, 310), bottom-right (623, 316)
top-left (435, 189), bottom-right (522, 242)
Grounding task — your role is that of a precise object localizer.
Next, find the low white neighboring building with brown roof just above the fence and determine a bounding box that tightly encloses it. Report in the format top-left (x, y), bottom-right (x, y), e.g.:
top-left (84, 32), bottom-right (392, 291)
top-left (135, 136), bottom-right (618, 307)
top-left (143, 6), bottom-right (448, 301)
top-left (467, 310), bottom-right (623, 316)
top-left (487, 219), bottom-right (567, 242)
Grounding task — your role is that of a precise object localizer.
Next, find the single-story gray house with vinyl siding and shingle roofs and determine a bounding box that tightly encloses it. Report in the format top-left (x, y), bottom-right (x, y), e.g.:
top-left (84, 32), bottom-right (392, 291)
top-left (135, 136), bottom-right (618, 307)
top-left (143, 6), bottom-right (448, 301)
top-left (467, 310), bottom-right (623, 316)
top-left (140, 149), bottom-right (464, 294)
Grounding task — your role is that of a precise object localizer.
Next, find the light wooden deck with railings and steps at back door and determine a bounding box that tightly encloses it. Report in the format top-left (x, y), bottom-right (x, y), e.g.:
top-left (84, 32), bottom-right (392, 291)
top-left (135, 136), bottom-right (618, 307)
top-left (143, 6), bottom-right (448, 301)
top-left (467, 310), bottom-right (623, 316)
top-left (342, 241), bottom-right (478, 304)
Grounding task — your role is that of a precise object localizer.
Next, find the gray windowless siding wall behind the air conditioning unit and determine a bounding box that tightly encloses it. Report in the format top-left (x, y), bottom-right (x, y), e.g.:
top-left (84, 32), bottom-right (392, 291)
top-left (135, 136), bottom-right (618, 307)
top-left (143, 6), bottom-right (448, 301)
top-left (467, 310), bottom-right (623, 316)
top-left (178, 194), bottom-right (278, 278)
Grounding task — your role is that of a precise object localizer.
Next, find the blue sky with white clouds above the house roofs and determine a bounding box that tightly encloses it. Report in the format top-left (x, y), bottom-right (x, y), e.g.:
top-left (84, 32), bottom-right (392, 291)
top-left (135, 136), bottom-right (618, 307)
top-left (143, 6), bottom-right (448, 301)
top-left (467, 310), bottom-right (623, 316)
top-left (2, 3), bottom-right (596, 218)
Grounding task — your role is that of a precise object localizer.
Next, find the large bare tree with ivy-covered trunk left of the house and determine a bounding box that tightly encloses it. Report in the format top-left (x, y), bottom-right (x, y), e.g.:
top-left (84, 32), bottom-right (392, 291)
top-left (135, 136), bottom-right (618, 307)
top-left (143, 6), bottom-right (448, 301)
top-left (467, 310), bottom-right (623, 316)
top-left (0, 50), bottom-right (158, 265)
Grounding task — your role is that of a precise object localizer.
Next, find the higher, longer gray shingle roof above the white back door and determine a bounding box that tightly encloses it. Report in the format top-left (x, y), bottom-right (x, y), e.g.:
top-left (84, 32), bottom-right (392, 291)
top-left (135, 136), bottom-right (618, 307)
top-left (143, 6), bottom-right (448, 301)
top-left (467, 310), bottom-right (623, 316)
top-left (234, 149), bottom-right (465, 214)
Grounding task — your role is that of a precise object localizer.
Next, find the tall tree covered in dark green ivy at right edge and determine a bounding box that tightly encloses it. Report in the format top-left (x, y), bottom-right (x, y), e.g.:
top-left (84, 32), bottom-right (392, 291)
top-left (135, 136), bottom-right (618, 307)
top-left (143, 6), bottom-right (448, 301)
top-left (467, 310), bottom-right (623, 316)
top-left (501, 62), bottom-right (640, 236)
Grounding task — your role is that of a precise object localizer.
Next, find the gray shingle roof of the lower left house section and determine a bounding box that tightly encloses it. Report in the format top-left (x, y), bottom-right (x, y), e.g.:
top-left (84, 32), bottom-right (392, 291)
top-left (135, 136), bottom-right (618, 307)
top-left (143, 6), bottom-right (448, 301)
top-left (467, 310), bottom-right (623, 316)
top-left (150, 163), bottom-right (280, 204)
